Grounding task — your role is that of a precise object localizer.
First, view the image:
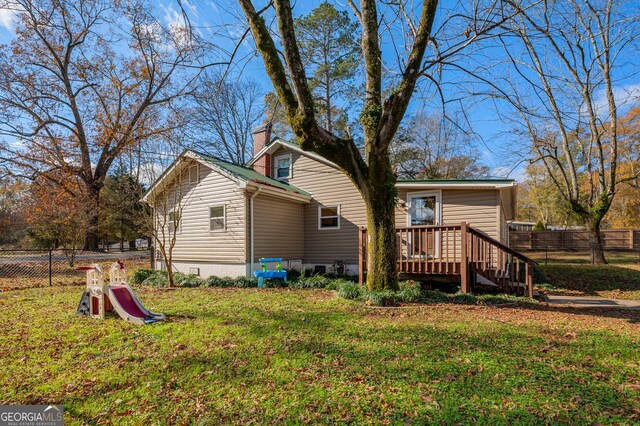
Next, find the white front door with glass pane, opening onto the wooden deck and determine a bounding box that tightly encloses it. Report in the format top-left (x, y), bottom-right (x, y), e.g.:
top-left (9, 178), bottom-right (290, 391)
top-left (400, 191), bottom-right (442, 258)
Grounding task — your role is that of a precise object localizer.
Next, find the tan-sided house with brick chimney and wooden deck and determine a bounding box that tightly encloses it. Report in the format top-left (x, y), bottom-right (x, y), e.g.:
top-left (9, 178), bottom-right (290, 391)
top-left (144, 126), bottom-right (536, 289)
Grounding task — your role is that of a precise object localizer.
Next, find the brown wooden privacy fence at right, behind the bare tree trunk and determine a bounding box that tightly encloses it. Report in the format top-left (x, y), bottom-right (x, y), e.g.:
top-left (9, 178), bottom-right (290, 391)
top-left (509, 229), bottom-right (640, 251)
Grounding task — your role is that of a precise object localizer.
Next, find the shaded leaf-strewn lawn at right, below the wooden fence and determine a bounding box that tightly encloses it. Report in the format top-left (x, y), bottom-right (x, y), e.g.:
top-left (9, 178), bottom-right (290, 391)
top-left (528, 252), bottom-right (640, 300)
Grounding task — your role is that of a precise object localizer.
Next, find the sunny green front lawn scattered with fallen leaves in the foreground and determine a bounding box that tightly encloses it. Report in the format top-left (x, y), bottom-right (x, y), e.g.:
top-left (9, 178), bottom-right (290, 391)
top-left (0, 287), bottom-right (640, 425)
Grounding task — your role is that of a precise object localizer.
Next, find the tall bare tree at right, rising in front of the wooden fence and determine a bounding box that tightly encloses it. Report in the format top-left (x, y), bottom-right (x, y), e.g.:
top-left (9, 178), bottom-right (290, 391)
top-left (484, 0), bottom-right (640, 263)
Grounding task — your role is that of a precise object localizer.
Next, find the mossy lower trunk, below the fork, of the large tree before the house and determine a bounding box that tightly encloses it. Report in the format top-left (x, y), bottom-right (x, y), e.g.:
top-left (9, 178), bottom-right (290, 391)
top-left (364, 161), bottom-right (398, 290)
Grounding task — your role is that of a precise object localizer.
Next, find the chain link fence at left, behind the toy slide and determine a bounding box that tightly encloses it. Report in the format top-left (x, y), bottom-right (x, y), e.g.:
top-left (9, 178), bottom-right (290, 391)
top-left (0, 249), bottom-right (151, 291)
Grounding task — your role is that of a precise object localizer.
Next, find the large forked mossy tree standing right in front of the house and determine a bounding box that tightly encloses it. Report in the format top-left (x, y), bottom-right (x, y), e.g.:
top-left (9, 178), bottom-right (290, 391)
top-left (238, 0), bottom-right (508, 289)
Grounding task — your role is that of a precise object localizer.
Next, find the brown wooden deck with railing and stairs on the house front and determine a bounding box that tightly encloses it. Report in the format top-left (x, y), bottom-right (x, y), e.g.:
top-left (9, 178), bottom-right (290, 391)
top-left (359, 223), bottom-right (535, 297)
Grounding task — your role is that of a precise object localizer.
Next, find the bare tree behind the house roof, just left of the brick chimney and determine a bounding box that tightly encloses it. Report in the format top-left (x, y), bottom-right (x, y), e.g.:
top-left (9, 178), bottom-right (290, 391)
top-left (190, 72), bottom-right (264, 164)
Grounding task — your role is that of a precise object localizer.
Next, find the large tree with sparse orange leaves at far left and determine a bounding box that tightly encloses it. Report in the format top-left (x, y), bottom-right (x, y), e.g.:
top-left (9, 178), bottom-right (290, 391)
top-left (0, 0), bottom-right (200, 249)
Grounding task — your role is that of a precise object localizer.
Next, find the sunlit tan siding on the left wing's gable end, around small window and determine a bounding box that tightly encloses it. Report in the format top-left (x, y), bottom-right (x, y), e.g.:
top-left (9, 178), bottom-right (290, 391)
top-left (157, 164), bottom-right (246, 263)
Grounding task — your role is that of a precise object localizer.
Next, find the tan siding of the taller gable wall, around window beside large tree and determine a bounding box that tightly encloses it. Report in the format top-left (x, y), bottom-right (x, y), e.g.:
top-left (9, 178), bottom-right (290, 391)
top-left (272, 148), bottom-right (367, 263)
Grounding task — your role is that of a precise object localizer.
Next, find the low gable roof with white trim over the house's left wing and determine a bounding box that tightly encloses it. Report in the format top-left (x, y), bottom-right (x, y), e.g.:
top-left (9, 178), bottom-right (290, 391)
top-left (142, 149), bottom-right (311, 202)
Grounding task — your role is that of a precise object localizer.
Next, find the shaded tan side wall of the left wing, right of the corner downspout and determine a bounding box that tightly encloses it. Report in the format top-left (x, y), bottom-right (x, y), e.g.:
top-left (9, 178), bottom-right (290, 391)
top-left (253, 194), bottom-right (304, 261)
